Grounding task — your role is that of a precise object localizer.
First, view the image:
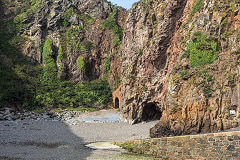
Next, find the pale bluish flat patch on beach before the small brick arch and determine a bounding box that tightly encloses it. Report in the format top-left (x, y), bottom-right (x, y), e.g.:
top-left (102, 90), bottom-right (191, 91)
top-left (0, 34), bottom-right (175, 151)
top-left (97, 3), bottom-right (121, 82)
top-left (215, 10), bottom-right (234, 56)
top-left (80, 111), bottom-right (121, 123)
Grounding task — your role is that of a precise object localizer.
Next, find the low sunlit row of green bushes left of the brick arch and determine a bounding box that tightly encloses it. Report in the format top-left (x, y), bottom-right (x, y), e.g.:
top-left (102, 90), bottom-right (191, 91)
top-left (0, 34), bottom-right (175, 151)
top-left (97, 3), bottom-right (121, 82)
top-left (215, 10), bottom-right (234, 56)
top-left (37, 80), bottom-right (112, 108)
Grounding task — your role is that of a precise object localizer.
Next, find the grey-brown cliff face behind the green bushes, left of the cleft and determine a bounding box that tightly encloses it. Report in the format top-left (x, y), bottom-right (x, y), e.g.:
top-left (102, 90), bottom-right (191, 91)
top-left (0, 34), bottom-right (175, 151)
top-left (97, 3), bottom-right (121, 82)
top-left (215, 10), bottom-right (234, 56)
top-left (3, 0), bottom-right (126, 83)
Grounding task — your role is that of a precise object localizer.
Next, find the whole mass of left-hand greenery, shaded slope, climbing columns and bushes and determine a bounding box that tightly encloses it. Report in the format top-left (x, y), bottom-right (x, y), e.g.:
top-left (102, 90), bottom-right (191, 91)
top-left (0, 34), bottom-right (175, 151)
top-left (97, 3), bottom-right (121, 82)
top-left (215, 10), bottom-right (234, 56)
top-left (0, 8), bottom-right (112, 109)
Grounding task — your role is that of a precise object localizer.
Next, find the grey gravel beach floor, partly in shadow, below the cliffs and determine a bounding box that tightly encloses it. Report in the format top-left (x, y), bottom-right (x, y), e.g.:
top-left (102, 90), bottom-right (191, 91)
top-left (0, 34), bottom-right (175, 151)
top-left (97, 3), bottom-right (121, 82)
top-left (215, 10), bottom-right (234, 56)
top-left (0, 111), bottom-right (159, 160)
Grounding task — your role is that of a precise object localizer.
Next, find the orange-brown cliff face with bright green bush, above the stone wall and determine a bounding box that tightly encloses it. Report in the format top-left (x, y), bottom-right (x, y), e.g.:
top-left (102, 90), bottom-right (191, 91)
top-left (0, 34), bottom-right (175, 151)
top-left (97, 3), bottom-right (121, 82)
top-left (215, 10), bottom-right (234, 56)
top-left (151, 0), bottom-right (240, 137)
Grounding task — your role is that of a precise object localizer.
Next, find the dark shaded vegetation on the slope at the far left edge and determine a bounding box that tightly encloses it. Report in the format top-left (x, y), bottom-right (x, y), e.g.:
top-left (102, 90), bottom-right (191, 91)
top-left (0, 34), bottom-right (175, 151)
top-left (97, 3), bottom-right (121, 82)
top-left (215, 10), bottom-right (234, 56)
top-left (0, 28), bottom-right (39, 108)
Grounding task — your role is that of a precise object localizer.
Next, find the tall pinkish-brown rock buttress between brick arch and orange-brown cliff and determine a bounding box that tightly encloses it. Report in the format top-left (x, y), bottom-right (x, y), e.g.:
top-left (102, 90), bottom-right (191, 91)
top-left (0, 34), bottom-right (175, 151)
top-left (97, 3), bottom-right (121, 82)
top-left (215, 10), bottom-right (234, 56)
top-left (121, 0), bottom-right (187, 123)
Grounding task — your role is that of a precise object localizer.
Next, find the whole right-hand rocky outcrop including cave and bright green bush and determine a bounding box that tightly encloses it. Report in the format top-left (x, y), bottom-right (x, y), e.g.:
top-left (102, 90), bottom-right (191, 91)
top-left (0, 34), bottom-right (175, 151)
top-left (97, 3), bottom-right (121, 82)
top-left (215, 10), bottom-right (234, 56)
top-left (121, 0), bottom-right (240, 137)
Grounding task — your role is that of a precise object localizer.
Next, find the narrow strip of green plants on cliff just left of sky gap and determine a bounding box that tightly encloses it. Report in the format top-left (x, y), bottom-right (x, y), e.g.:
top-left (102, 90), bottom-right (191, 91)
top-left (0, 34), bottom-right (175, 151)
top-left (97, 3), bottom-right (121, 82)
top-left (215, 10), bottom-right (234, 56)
top-left (101, 8), bottom-right (123, 52)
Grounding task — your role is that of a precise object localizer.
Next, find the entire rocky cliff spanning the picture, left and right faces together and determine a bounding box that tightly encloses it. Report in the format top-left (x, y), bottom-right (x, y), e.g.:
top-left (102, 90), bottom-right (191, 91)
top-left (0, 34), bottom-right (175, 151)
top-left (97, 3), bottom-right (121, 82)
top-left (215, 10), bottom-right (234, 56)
top-left (1, 0), bottom-right (240, 137)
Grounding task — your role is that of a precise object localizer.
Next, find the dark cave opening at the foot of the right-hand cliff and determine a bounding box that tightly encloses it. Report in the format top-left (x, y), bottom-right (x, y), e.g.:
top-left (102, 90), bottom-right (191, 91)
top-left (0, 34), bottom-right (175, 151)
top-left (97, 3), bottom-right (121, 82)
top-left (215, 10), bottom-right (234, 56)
top-left (142, 103), bottom-right (162, 121)
